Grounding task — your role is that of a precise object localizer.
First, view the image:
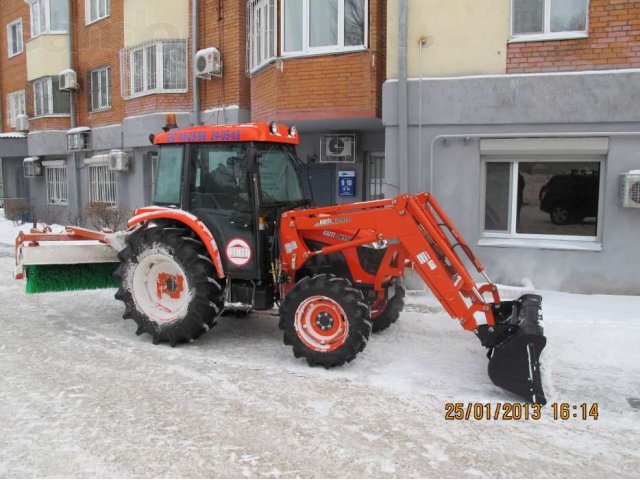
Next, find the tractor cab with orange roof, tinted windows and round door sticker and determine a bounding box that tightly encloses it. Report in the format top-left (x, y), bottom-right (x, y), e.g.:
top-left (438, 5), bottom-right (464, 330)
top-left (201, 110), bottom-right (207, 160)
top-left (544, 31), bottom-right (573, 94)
top-left (153, 123), bottom-right (309, 304)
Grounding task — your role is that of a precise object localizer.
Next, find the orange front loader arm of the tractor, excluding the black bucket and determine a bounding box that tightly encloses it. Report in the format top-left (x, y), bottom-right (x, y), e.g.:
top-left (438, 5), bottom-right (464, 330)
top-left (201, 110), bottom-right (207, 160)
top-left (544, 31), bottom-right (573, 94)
top-left (281, 193), bottom-right (500, 331)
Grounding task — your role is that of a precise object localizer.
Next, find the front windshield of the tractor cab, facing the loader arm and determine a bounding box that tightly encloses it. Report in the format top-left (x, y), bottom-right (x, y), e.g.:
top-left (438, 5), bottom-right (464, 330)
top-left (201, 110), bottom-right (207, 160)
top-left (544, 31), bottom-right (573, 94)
top-left (257, 144), bottom-right (304, 204)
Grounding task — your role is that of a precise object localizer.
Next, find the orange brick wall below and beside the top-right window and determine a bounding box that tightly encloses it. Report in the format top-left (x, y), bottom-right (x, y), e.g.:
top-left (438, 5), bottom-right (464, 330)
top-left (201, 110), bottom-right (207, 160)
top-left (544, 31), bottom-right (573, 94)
top-left (507, 0), bottom-right (640, 73)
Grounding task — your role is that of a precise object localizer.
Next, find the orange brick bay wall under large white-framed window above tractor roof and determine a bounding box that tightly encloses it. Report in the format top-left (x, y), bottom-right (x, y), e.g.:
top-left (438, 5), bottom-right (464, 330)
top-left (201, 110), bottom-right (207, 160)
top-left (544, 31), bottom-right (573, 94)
top-left (251, 0), bottom-right (386, 121)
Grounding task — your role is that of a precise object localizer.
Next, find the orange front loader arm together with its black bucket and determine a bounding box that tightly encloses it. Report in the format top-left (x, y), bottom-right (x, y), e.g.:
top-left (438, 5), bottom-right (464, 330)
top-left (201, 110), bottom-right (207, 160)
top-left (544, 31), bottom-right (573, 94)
top-left (280, 193), bottom-right (546, 404)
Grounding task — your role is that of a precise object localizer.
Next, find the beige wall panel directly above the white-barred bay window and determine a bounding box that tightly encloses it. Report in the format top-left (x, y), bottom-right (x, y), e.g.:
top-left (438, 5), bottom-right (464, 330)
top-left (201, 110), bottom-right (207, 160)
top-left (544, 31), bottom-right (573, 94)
top-left (124, 0), bottom-right (191, 47)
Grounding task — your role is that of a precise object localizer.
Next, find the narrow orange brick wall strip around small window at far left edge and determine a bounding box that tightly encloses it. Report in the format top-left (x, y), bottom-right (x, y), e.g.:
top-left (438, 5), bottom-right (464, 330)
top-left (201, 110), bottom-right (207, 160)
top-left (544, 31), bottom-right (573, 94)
top-left (0, 0), bottom-right (31, 132)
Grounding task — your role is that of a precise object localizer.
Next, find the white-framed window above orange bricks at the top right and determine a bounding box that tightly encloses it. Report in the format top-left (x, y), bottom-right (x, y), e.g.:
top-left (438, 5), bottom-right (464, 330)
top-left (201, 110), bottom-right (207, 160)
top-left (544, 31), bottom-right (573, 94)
top-left (511, 0), bottom-right (589, 40)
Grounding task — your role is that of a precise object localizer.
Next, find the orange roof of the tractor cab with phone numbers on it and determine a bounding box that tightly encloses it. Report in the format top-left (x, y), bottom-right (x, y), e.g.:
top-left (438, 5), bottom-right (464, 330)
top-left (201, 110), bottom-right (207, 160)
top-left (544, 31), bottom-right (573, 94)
top-left (153, 123), bottom-right (300, 145)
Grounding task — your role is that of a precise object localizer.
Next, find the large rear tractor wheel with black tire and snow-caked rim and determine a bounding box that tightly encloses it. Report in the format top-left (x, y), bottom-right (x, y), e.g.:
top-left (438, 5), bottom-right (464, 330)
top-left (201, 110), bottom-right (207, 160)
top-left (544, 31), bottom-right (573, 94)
top-left (113, 227), bottom-right (224, 347)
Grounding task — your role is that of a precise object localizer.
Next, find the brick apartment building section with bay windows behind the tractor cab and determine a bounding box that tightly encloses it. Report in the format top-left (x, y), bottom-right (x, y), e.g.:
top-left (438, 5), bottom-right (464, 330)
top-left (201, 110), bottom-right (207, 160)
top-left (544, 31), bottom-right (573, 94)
top-left (0, 0), bottom-right (386, 223)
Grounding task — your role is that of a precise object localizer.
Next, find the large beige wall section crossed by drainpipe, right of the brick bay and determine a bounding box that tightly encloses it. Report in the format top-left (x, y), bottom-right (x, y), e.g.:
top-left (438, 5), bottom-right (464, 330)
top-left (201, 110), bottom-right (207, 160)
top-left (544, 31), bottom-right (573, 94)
top-left (387, 0), bottom-right (510, 78)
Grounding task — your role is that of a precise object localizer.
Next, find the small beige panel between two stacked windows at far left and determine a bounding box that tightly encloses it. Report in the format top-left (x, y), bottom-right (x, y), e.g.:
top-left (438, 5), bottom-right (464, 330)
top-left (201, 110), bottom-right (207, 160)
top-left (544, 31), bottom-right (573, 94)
top-left (27, 34), bottom-right (69, 81)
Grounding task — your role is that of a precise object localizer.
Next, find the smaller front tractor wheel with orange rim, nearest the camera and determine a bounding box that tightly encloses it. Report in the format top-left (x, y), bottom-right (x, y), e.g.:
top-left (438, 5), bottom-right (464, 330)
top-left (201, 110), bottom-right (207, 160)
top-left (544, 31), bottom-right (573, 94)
top-left (280, 274), bottom-right (371, 368)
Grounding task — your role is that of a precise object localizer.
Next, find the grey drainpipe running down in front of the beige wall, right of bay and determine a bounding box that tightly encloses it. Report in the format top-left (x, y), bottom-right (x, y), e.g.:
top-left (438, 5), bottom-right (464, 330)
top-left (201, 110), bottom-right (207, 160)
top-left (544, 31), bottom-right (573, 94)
top-left (398, 0), bottom-right (409, 193)
